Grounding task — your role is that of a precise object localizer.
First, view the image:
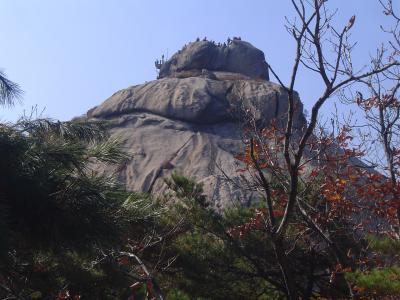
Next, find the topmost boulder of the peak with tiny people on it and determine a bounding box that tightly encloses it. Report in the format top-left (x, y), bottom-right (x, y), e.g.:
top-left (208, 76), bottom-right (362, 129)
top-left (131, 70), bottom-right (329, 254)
top-left (159, 39), bottom-right (269, 80)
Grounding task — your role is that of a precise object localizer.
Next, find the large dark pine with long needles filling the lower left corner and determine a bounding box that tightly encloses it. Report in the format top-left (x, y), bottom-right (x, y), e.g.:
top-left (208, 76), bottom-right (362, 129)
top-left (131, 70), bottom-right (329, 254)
top-left (0, 116), bottom-right (167, 299)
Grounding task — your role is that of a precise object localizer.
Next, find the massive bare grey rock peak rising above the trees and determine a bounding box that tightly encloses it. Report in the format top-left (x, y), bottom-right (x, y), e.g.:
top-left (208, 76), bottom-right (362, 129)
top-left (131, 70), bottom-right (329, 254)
top-left (83, 39), bottom-right (305, 209)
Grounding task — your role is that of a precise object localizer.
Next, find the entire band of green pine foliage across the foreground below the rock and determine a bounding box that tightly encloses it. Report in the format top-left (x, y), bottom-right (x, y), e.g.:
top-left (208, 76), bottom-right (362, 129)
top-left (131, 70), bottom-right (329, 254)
top-left (0, 72), bottom-right (400, 300)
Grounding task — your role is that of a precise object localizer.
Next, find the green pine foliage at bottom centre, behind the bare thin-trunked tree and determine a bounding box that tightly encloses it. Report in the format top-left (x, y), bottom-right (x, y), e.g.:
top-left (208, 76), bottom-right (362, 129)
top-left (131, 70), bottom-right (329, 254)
top-left (162, 174), bottom-right (382, 299)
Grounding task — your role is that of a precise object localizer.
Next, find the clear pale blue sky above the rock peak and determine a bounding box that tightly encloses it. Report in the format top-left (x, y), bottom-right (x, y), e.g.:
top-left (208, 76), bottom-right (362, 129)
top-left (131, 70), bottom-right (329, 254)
top-left (0, 0), bottom-right (394, 120)
